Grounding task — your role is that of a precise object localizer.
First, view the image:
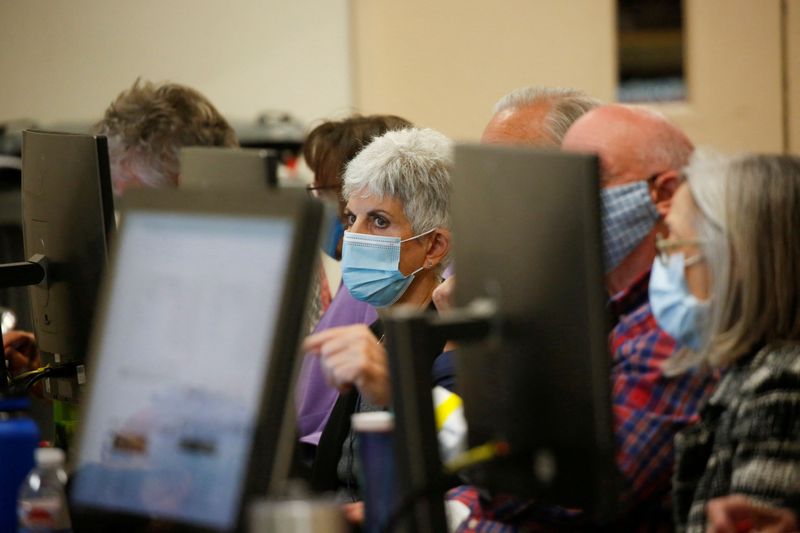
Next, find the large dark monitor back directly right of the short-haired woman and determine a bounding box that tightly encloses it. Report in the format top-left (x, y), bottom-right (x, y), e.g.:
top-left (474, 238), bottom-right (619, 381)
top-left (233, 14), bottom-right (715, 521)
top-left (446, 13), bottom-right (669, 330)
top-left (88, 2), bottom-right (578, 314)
top-left (453, 145), bottom-right (617, 512)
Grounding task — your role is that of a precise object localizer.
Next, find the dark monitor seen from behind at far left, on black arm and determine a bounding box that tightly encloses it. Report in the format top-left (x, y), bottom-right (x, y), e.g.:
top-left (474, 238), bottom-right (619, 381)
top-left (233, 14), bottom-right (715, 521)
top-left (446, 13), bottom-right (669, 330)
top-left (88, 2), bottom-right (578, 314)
top-left (22, 130), bottom-right (114, 374)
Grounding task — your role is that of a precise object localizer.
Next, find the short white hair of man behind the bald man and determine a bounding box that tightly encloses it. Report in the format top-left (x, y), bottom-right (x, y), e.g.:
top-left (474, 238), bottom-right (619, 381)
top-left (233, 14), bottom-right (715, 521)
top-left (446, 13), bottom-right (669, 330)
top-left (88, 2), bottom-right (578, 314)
top-left (494, 86), bottom-right (602, 144)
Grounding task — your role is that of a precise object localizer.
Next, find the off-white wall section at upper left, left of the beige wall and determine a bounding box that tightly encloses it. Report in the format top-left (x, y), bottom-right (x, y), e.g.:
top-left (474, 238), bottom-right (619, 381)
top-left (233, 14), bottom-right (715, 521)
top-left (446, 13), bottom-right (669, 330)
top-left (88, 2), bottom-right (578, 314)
top-left (0, 0), bottom-right (352, 126)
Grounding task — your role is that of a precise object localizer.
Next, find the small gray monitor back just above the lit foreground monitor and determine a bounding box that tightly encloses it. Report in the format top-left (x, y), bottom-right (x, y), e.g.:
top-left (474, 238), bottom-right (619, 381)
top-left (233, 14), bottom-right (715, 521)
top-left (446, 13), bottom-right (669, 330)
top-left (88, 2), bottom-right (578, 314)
top-left (179, 146), bottom-right (278, 191)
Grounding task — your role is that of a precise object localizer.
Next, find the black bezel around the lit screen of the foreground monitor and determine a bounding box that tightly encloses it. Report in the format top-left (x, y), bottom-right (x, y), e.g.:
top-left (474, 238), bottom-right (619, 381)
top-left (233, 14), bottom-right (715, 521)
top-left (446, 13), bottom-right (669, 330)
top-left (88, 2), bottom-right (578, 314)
top-left (70, 190), bottom-right (322, 533)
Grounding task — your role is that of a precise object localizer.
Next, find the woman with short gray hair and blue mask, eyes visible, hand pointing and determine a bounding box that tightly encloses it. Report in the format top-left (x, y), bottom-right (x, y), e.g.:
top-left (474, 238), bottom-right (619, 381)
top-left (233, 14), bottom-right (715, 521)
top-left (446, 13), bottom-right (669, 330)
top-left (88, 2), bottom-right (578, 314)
top-left (304, 128), bottom-right (453, 496)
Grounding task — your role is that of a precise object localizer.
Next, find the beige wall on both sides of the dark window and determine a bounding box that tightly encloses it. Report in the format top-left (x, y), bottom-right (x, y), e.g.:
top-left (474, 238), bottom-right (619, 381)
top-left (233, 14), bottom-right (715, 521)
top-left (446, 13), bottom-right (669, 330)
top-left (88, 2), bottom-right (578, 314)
top-left (352, 0), bottom-right (788, 151)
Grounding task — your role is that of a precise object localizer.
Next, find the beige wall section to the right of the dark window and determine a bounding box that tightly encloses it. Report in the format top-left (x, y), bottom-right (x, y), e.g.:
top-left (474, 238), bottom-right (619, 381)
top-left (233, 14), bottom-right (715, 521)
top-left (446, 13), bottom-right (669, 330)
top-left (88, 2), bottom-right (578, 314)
top-left (664, 0), bottom-right (783, 152)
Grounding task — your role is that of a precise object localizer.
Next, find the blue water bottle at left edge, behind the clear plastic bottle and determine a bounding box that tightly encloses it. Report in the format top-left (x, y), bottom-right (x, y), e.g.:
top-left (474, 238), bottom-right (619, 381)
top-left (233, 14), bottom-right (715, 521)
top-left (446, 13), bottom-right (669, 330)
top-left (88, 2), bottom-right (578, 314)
top-left (0, 392), bottom-right (39, 532)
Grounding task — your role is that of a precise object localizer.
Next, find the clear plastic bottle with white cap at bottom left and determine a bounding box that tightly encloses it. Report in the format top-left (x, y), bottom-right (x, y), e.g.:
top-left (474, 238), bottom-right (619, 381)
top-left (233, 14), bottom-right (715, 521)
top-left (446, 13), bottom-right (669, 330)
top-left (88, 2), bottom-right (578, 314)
top-left (17, 448), bottom-right (72, 533)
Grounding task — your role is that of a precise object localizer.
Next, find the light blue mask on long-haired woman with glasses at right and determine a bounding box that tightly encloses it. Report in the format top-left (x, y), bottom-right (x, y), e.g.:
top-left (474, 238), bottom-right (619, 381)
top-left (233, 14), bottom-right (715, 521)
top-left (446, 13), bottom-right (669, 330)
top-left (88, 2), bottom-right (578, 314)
top-left (649, 253), bottom-right (709, 351)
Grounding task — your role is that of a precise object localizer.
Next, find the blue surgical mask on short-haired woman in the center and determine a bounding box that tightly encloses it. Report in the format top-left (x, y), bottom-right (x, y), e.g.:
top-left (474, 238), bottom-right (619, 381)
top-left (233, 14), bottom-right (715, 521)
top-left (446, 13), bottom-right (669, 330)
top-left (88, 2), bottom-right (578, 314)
top-left (342, 230), bottom-right (434, 307)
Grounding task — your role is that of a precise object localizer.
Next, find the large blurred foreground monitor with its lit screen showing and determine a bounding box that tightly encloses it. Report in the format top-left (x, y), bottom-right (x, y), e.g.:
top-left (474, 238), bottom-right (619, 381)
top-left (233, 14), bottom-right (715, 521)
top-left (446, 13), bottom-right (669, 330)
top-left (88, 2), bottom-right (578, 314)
top-left (70, 190), bottom-right (322, 531)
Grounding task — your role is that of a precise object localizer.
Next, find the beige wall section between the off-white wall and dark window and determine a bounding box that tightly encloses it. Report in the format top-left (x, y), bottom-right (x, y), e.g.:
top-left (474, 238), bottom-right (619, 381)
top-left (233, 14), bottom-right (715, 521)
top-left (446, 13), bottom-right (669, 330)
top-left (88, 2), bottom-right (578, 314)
top-left (352, 0), bottom-right (615, 140)
